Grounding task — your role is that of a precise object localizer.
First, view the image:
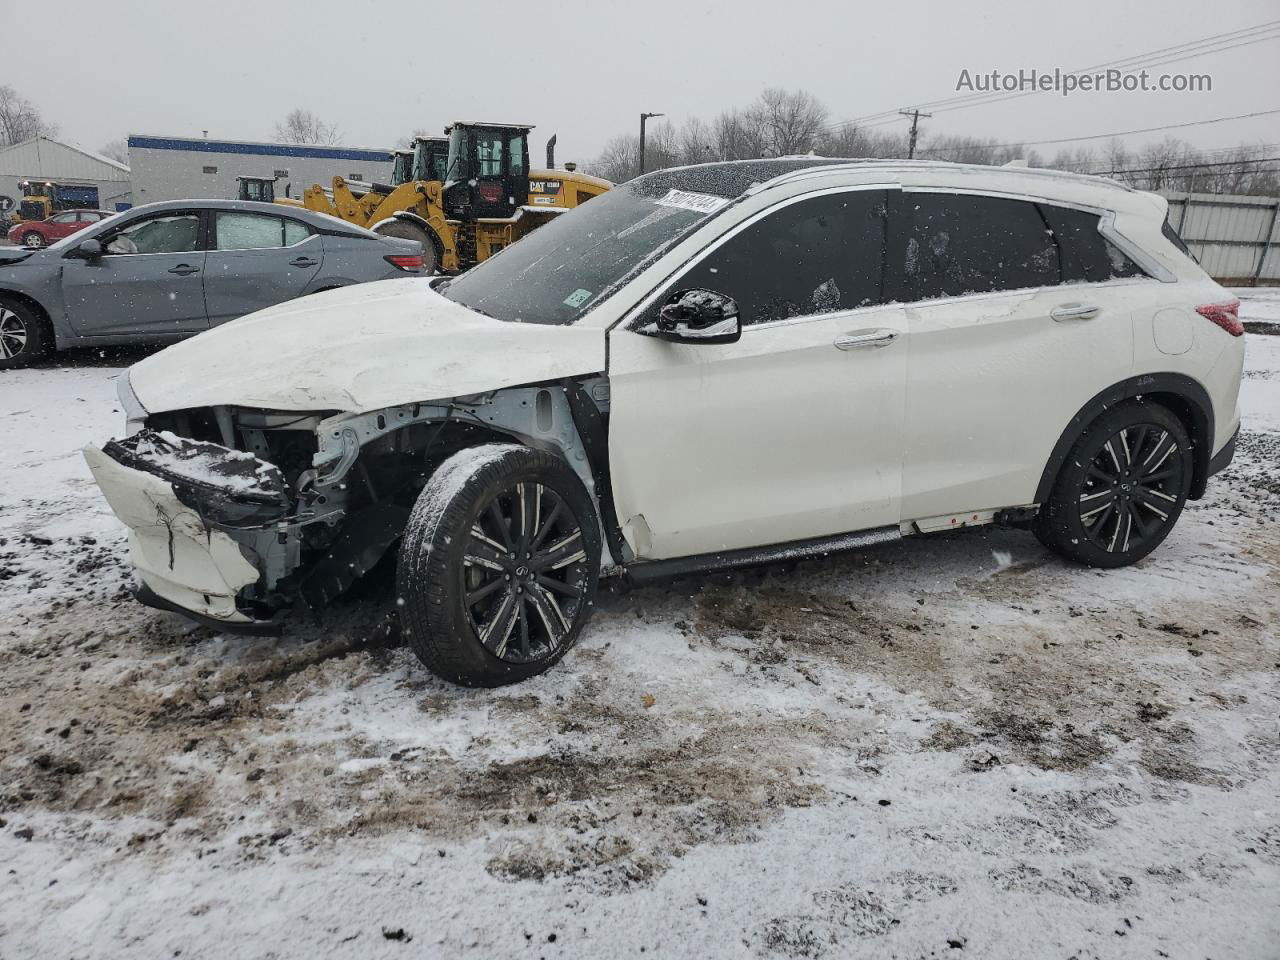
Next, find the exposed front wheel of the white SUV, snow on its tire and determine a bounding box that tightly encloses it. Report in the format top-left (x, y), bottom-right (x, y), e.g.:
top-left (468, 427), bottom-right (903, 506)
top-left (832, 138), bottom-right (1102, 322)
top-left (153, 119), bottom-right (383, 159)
top-left (397, 444), bottom-right (600, 686)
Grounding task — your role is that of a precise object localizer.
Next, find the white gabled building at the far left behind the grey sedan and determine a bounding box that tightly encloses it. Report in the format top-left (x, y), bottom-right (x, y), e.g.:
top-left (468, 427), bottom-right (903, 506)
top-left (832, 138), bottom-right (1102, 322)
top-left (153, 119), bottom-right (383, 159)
top-left (0, 137), bottom-right (133, 214)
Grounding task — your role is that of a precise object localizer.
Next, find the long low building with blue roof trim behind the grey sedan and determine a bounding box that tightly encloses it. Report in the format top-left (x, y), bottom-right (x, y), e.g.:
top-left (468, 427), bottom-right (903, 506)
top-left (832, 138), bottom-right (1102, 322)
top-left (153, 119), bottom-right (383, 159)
top-left (129, 134), bottom-right (393, 204)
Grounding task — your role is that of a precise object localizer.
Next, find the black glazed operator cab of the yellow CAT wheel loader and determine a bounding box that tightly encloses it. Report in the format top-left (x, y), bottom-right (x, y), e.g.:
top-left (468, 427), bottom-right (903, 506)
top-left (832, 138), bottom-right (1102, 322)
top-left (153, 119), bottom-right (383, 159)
top-left (444, 123), bottom-right (532, 220)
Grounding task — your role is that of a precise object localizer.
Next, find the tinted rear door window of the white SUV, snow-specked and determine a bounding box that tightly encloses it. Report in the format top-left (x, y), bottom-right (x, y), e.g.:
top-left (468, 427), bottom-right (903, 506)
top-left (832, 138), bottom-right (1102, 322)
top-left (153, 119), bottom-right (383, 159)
top-left (890, 193), bottom-right (1061, 301)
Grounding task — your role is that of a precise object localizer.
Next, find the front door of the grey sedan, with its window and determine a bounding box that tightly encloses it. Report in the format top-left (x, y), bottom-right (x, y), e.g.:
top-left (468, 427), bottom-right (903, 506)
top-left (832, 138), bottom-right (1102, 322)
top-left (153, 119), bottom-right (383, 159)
top-left (61, 210), bottom-right (207, 337)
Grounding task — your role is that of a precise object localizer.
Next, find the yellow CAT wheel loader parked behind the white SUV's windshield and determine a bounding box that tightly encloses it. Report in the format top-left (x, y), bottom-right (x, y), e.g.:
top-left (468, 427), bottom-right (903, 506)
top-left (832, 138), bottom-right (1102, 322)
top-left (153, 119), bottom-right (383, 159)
top-left (294, 123), bottom-right (613, 273)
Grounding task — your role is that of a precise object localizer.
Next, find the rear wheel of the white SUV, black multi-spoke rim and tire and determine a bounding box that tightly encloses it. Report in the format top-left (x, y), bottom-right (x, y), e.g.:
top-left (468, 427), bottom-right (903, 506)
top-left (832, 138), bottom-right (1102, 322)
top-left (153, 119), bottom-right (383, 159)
top-left (1032, 401), bottom-right (1193, 567)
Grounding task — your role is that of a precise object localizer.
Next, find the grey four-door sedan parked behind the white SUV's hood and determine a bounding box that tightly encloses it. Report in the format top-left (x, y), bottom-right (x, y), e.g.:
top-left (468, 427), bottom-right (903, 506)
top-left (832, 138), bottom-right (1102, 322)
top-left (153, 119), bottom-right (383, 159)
top-left (0, 200), bottom-right (422, 370)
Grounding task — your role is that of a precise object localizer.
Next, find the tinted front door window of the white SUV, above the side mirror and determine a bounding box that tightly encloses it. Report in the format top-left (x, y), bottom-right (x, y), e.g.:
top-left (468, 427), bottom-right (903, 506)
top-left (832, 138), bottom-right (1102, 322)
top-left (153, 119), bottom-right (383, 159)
top-left (675, 191), bottom-right (886, 326)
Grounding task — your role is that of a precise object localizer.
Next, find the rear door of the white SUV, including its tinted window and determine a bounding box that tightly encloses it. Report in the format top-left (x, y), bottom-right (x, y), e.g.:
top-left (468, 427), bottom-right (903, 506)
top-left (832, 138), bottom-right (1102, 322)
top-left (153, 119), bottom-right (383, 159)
top-left (888, 189), bottom-right (1140, 520)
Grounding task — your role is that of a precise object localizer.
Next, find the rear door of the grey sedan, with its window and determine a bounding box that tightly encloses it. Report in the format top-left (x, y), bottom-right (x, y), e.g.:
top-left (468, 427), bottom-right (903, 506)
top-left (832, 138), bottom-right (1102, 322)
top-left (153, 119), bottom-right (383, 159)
top-left (205, 210), bottom-right (324, 325)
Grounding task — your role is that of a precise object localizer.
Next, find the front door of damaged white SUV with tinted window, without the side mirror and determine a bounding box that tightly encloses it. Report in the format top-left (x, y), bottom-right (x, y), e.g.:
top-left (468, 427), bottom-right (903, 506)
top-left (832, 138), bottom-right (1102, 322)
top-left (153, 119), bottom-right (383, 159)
top-left (608, 191), bottom-right (906, 559)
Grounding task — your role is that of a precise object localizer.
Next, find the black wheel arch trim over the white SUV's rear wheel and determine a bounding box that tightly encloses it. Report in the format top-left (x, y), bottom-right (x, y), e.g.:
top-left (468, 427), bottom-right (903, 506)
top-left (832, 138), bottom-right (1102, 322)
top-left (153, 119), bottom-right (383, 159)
top-left (1034, 372), bottom-right (1213, 503)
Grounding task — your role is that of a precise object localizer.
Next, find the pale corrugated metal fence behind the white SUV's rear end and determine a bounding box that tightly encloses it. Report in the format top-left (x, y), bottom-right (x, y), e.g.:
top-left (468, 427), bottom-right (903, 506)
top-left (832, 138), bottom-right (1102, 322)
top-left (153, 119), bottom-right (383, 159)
top-left (1161, 191), bottom-right (1280, 287)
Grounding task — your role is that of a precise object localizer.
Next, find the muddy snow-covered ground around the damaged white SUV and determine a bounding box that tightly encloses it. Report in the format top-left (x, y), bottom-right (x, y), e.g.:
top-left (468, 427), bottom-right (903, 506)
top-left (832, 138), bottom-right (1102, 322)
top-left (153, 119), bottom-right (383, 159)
top-left (0, 300), bottom-right (1280, 960)
